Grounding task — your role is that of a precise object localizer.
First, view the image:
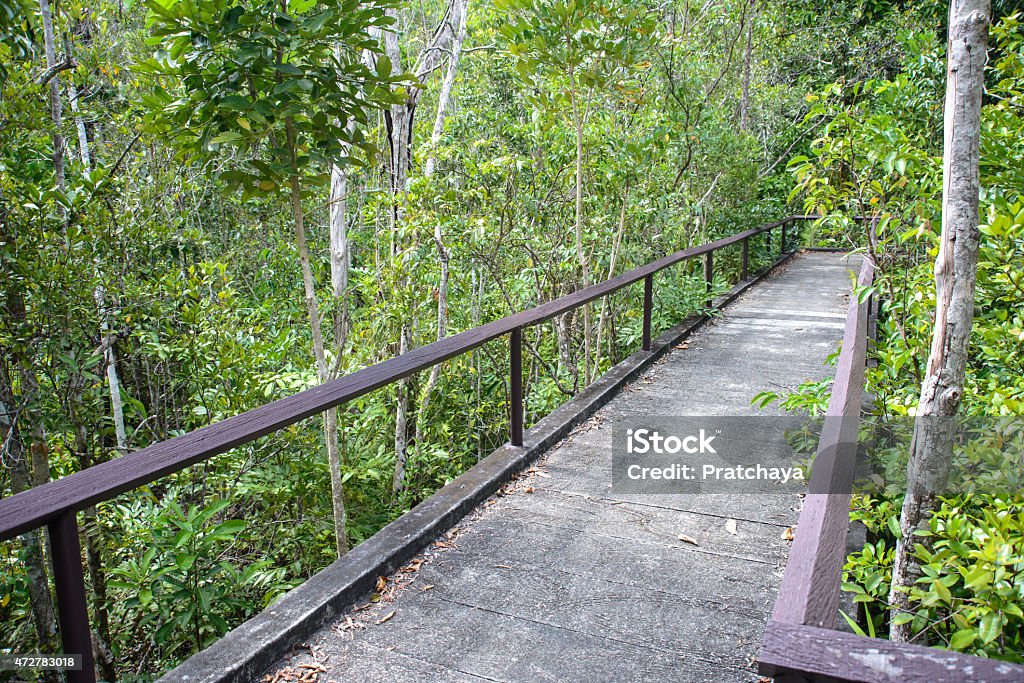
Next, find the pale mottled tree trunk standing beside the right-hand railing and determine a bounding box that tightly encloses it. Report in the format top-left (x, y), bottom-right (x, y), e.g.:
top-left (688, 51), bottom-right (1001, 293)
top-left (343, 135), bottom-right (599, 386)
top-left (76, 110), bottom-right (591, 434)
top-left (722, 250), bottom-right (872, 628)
top-left (889, 0), bottom-right (990, 641)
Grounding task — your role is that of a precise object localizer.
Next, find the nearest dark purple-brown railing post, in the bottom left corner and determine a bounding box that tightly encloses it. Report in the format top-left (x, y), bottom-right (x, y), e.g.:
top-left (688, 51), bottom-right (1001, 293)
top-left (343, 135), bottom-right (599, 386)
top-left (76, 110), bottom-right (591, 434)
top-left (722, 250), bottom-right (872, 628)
top-left (47, 510), bottom-right (96, 683)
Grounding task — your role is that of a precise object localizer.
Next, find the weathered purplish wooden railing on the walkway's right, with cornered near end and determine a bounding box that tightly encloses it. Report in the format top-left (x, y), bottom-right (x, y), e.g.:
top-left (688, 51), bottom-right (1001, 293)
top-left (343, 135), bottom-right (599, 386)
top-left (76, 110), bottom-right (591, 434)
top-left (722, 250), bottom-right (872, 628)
top-left (759, 258), bottom-right (1024, 683)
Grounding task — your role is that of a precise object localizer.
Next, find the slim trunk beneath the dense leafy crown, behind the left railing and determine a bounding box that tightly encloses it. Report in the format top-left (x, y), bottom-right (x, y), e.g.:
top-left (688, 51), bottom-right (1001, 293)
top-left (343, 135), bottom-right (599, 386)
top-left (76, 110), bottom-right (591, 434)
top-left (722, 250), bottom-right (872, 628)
top-left (285, 118), bottom-right (348, 557)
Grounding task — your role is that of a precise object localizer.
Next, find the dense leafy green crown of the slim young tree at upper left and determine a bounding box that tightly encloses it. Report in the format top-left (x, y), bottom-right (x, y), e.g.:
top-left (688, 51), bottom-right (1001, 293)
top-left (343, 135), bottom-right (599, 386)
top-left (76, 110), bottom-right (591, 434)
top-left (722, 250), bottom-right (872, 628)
top-left (142, 0), bottom-right (407, 197)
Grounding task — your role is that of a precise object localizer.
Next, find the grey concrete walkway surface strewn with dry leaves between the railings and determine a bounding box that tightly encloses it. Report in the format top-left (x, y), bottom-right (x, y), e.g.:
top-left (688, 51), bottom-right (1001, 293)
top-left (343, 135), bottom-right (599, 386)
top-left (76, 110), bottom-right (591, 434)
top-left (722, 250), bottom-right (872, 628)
top-left (264, 253), bottom-right (857, 683)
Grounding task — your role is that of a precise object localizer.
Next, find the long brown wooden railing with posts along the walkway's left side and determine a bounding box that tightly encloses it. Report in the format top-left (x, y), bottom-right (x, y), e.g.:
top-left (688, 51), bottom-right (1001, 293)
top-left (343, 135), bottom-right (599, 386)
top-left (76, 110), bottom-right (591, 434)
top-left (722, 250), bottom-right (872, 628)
top-left (0, 216), bottom-right (798, 683)
